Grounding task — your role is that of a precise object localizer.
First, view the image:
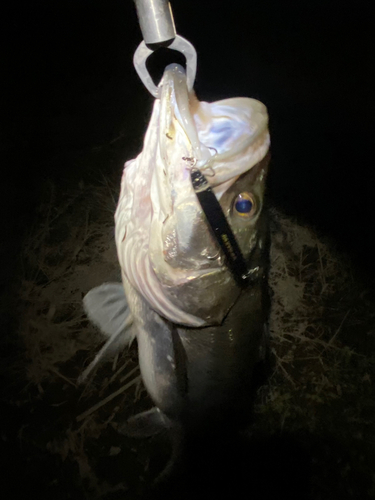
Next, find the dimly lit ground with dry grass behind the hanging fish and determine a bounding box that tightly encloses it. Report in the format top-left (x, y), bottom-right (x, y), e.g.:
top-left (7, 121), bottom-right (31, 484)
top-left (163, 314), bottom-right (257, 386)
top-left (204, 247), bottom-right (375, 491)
top-left (0, 141), bottom-right (375, 500)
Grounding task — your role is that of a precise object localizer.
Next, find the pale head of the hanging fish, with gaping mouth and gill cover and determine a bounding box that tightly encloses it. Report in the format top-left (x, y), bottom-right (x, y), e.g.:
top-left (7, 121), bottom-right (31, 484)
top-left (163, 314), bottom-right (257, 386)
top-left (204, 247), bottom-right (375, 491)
top-left (115, 64), bottom-right (270, 327)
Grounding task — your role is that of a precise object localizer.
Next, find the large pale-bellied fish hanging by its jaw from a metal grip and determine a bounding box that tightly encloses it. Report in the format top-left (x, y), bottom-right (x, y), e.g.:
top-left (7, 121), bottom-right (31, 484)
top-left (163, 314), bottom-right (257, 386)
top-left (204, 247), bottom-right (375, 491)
top-left (81, 64), bottom-right (270, 476)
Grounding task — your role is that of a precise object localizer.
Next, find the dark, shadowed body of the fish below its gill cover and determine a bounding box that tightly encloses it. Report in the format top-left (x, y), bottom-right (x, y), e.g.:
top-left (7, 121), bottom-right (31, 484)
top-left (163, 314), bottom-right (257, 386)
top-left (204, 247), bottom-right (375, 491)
top-left (119, 192), bottom-right (270, 488)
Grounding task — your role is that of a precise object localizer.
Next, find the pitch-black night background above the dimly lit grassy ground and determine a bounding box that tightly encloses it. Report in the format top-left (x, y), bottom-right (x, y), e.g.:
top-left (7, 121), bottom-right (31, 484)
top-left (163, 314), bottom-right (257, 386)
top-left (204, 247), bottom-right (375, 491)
top-left (0, 0), bottom-right (375, 285)
